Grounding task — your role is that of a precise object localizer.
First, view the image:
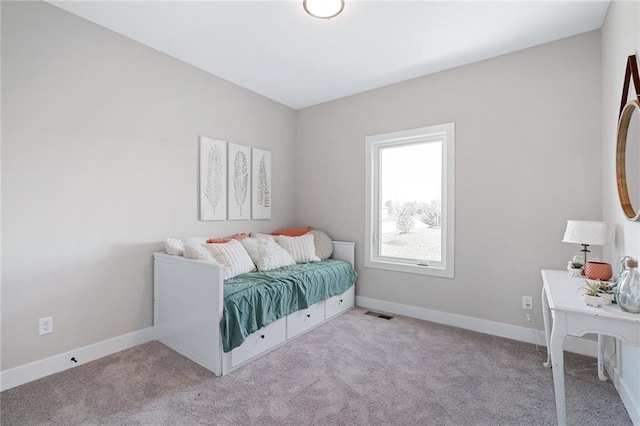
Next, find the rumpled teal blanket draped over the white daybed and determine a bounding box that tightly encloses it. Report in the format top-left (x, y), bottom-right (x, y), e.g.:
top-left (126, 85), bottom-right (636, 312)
top-left (220, 259), bottom-right (358, 352)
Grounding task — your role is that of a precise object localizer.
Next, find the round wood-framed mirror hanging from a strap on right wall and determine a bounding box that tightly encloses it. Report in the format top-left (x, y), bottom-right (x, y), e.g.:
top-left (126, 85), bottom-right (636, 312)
top-left (616, 100), bottom-right (640, 222)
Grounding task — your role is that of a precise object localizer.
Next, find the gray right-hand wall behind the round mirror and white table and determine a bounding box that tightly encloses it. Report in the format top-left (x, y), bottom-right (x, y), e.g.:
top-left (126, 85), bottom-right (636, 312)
top-left (602, 1), bottom-right (640, 413)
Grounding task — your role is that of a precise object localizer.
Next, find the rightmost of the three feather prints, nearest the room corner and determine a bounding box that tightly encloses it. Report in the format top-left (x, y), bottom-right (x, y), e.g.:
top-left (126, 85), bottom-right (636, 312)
top-left (251, 148), bottom-right (271, 219)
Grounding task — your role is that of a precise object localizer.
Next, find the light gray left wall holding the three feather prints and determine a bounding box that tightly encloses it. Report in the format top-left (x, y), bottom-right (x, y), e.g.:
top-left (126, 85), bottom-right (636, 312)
top-left (2, 1), bottom-right (295, 370)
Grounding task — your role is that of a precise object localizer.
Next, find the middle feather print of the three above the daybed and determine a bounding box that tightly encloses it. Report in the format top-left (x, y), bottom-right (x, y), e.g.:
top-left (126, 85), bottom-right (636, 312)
top-left (227, 143), bottom-right (251, 220)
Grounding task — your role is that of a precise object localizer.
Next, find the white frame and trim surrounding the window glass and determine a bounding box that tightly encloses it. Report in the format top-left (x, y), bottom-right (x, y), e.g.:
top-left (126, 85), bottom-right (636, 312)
top-left (364, 123), bottom-right (455, 278)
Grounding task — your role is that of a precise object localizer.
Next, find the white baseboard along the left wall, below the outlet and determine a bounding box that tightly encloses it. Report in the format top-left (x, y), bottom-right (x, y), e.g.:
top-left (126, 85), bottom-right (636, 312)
top-left (0, 327), bottom-right (153, 391)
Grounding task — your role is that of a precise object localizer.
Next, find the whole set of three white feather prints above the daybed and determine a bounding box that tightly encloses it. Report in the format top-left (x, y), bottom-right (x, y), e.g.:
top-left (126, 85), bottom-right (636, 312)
top-left (200, 136), bottom-right (271, 220)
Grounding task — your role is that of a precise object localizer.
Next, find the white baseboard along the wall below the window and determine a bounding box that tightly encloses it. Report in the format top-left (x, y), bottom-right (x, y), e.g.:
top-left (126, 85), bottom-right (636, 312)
top-left (356, 296), bottom-right (598, 357)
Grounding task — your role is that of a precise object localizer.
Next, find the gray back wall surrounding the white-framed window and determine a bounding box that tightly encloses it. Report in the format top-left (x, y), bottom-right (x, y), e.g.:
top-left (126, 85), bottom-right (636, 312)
top-left (295, 31), bottom-right (602, 326)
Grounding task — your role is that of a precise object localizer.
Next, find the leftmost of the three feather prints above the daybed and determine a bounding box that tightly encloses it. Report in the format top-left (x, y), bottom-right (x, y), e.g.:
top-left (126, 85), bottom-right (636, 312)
top-left (200, 136), bottom-right (227, 220)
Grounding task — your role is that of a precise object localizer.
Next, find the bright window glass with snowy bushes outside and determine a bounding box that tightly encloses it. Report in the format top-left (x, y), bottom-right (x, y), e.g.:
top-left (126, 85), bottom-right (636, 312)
top-left (378, 140), bottom-right (443, 262)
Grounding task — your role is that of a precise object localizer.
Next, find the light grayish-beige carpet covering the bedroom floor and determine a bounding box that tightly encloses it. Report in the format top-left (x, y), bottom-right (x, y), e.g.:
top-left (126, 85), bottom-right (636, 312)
top-left (0, 308), bottom-right (631, 426)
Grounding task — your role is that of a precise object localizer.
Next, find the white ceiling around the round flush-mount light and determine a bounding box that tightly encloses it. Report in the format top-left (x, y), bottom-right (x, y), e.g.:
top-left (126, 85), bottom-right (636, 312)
top-left (49, 0), bottom-right (609, 109)
